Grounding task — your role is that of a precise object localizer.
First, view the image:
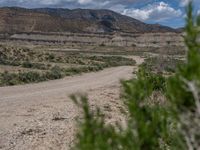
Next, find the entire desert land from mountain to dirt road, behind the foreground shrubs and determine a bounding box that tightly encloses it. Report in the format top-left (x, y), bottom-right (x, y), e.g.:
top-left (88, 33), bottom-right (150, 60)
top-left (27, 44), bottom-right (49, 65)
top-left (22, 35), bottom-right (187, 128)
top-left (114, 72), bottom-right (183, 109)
top-left (0, 2), bottom-right (198, 150)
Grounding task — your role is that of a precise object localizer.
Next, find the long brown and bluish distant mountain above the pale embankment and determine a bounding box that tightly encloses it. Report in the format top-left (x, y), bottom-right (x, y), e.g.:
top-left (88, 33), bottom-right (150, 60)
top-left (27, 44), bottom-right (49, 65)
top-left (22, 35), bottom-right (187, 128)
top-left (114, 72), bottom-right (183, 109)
top-left (0, 7), bottom-right (177, 33)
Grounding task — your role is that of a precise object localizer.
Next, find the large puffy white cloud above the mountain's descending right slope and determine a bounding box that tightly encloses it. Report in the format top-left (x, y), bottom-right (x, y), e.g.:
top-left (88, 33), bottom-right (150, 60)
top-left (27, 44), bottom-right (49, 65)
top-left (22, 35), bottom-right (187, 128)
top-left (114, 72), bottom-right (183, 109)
top-left (119, 2), bottom-right (182, 21)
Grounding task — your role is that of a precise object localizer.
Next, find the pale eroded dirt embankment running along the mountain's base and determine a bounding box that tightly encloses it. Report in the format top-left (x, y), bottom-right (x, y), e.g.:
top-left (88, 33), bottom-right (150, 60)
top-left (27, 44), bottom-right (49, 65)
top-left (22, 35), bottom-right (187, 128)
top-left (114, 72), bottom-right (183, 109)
top-left (1, 32), bottom-right (184, 47)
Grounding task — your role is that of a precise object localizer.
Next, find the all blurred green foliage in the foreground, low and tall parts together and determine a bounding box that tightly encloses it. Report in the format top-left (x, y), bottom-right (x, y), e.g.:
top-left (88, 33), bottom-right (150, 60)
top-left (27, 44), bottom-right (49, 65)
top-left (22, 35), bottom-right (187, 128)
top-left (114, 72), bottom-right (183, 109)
top-left (72, 3), bottom-right (200, 150)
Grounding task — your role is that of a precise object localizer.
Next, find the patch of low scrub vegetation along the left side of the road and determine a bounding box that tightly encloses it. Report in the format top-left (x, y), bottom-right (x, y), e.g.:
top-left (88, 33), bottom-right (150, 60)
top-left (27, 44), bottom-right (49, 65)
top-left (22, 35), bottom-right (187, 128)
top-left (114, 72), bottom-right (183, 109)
top-left (0, 45), bottom-right (135, 86)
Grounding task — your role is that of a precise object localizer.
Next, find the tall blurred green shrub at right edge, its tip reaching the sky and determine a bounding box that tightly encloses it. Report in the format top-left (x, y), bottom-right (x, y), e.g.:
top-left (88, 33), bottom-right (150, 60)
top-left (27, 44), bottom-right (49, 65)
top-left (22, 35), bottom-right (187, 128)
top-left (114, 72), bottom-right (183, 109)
top-left (167, 3), bottom-right (200, 150)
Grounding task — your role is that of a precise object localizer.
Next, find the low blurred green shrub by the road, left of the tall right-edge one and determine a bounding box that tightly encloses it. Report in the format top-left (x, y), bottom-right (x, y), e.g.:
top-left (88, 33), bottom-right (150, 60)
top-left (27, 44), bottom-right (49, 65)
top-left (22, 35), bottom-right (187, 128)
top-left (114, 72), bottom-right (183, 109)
top-left (72, 69), bottom-right (185, 150)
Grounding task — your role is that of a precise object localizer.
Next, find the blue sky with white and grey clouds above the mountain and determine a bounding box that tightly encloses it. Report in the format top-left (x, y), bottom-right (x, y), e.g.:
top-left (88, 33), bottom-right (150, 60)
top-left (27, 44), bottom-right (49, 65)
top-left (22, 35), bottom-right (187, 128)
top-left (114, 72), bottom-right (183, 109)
top-left (0, 0), bottom-right (200, 28)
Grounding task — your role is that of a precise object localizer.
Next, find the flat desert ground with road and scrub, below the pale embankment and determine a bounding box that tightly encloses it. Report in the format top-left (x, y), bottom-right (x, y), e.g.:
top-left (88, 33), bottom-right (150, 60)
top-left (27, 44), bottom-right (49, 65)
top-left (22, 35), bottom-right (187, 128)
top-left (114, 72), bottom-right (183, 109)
top-left (0, 39), bottom-right (184, 150)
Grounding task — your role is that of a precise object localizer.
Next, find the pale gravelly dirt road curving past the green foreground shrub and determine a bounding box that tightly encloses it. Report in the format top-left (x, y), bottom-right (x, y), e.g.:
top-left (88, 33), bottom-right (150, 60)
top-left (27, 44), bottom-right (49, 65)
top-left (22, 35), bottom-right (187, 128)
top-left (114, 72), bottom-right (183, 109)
top-left (0, 66), bottom-right (140, 150)
